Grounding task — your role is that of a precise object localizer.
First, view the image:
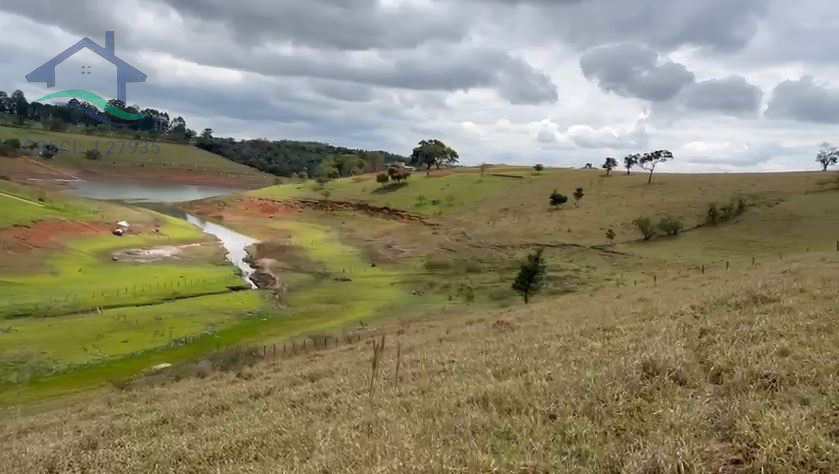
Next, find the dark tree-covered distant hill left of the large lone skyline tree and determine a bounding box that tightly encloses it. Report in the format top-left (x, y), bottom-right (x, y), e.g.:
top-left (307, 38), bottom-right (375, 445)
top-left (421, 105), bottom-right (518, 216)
top-left (196, 138), bottom-right (408, 178)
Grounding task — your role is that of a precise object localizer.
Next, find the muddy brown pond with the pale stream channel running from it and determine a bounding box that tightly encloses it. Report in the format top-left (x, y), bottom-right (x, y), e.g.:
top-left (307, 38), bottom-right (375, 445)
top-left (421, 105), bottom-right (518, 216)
top-left (65, 181), bottom-right (257, 288)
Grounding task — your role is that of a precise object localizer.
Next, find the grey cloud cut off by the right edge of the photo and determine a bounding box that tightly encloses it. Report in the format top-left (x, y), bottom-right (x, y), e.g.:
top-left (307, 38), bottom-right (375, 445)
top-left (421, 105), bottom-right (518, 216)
top-left (766, 76), bottom-right (839, 123)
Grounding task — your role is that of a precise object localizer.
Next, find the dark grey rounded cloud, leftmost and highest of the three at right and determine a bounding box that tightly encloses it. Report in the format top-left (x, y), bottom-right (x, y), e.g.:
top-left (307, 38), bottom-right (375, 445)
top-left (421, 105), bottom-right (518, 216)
top-left (580, 43), bottom-right (694, 101)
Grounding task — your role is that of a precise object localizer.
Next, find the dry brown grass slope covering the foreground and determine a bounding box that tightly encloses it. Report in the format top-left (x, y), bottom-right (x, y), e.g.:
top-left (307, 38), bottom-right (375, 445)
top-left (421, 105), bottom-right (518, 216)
top-left (0, 254), bottom-right (839, 473)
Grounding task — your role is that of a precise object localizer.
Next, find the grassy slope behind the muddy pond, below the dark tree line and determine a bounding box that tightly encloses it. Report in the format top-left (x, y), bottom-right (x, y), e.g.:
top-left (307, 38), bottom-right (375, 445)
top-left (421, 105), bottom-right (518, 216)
top-left (0, 127), bottom-right (274, 188)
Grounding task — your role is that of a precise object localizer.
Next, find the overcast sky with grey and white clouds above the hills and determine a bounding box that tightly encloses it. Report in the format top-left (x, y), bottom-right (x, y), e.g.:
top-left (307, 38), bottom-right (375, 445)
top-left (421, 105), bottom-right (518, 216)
top-left (0, 0), bottom-right (839, 171)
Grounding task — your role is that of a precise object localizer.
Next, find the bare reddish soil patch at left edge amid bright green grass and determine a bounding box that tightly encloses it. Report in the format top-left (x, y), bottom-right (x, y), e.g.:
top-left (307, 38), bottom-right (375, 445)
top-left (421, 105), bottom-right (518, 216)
top-left (0, 220), bottom-right (117, 253)
